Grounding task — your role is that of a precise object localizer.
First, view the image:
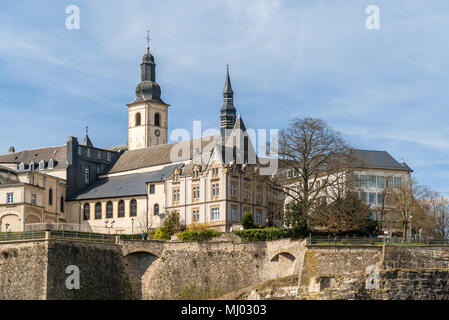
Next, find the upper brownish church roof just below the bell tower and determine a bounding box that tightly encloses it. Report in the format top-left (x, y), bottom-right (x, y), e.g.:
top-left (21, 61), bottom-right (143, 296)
top-left (106, 135), bottom-right (221, 174)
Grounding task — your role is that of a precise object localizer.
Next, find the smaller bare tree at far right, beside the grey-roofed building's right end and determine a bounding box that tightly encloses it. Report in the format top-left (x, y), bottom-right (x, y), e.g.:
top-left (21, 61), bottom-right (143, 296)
top-left (385, 178), bottom-right (426, 240)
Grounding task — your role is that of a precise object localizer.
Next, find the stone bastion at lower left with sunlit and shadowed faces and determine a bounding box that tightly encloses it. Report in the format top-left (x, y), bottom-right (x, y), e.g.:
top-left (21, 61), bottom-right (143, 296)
top-left (0, 240), bottom-right (133, 300)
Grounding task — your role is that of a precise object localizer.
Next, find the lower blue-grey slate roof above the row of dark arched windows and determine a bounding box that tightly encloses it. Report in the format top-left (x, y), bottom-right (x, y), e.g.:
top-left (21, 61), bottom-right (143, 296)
top-left (69, 165), bottom-right (181, 200)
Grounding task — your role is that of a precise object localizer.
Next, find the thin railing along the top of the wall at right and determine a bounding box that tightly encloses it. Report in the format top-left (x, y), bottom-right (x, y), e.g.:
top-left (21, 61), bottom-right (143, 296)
top-left (307, 236), bottom-right (449, 246)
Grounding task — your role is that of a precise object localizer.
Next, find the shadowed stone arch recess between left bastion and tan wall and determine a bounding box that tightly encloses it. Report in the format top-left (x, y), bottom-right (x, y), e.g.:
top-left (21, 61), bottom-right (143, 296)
top-left (123, 250), bottom-right (158, 300)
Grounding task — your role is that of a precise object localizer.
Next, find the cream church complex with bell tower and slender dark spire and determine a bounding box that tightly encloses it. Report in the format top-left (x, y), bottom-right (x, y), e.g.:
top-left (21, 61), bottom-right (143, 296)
top-left (0, 46), bottom-right (276, 234)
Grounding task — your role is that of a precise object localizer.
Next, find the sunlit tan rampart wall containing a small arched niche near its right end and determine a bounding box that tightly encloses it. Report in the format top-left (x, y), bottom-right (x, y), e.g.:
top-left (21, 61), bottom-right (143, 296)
top-left (142, 240), bottom-right (301, 299)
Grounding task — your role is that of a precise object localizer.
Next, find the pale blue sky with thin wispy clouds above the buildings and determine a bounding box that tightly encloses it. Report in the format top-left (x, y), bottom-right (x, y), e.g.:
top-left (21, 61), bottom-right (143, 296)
top-left (0, 0), bottom-right (449, 192)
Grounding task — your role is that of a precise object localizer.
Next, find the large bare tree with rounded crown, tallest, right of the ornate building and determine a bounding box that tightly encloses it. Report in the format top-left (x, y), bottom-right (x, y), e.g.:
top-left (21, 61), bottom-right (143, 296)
top-left (268, 118), bottom-right (351, 224)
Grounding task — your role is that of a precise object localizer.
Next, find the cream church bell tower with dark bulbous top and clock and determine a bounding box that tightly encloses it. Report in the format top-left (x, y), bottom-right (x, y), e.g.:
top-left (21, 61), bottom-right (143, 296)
top-left (128, 34), bottom-right (169, 150)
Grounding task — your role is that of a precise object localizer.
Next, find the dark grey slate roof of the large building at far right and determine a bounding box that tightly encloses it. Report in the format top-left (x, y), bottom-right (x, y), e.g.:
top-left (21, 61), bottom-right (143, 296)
top-left (353, 149), bottom-right (413, 172)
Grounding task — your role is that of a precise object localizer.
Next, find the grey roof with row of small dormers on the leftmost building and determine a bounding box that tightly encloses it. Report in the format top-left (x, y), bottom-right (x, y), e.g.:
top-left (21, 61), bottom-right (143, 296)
top-left (0, 145), bottom-right (67, 169)
